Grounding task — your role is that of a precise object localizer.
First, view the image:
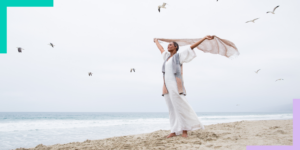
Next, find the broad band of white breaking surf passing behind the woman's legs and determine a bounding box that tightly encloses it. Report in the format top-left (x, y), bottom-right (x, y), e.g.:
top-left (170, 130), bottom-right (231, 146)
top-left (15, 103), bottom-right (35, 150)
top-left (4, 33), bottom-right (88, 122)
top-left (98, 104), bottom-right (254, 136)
top-left (0, 114), bottom-right (293, 132)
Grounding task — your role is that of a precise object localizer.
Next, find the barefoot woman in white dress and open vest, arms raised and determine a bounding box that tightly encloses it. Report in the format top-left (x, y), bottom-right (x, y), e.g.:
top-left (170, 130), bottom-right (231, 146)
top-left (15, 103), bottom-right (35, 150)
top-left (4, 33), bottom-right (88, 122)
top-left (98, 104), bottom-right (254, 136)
top-left (154, 36), bottom-right (214, 138)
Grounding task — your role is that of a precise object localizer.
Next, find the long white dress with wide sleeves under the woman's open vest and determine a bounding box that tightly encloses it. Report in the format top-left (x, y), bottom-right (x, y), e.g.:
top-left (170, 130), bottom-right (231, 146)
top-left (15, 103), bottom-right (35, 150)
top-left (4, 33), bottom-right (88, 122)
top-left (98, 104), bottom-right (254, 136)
top-left (162, 47), bottom-right (204, 135)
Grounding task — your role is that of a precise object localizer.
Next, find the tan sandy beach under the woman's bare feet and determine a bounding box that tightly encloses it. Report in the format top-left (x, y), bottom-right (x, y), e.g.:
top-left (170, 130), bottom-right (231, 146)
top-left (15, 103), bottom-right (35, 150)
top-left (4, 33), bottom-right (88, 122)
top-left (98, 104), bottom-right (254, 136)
top-left (16, 120), bottom-right (293, 150)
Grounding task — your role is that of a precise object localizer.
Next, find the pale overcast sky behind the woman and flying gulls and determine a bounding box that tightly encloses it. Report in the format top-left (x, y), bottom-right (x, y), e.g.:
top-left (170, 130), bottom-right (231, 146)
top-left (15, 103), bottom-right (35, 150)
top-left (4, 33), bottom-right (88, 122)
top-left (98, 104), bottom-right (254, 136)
top-left (0, 0), bottom-right (300, 112)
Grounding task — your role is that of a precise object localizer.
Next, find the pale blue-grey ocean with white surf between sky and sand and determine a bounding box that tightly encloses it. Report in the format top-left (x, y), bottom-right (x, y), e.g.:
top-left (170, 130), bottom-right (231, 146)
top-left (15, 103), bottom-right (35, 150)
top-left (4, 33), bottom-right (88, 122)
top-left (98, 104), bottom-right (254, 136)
top-left (0, 112), bottom-right (293, 150)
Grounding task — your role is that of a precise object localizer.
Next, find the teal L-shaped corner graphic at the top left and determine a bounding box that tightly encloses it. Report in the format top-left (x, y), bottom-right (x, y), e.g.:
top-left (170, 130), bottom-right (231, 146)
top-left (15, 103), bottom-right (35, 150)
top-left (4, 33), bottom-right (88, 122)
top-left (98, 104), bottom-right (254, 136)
top-left (0, 0), bottom-right (54, 54)
